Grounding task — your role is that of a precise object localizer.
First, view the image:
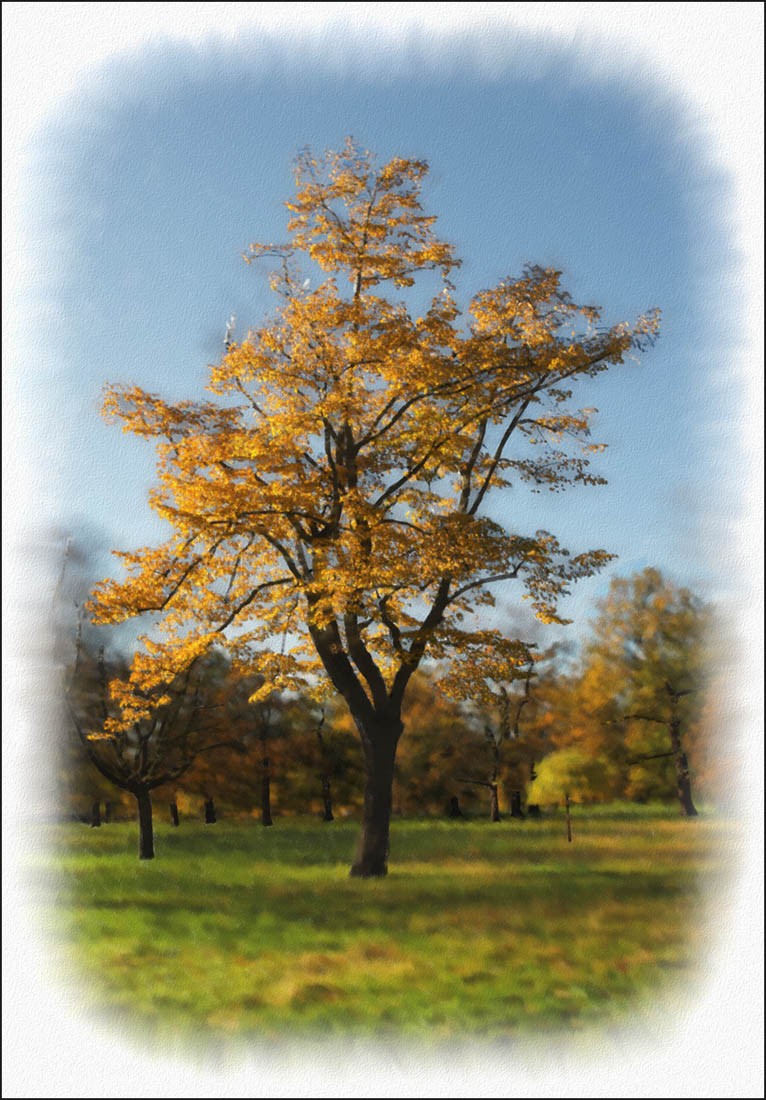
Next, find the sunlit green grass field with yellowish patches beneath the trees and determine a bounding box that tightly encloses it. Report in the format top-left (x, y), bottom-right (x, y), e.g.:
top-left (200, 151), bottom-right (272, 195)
top-left (26, 806), bottom-right (735, 1040)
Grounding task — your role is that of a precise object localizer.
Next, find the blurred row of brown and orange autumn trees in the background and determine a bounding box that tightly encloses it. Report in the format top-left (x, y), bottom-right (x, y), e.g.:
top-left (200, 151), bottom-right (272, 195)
top-left (58, 569), bottom-right (715, 840)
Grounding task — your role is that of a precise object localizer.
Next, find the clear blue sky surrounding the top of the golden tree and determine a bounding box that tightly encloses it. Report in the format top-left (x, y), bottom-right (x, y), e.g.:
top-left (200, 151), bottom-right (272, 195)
top-left (17, 31), bottom-right (733, 637)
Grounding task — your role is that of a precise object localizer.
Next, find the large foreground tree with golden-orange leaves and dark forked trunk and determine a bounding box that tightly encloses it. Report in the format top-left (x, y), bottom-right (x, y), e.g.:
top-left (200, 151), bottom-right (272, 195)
top-left (92, 140), bottom-right (658, 877)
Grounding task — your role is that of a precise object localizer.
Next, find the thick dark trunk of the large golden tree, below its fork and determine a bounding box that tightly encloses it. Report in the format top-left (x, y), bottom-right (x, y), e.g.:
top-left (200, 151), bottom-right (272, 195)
top-left (351, 721), bottom-right (403, 879)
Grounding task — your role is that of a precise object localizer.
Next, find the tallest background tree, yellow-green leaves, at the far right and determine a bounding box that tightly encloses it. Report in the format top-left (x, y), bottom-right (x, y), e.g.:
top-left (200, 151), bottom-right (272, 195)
top-left (587, 569), bottom-right (710, 817)
